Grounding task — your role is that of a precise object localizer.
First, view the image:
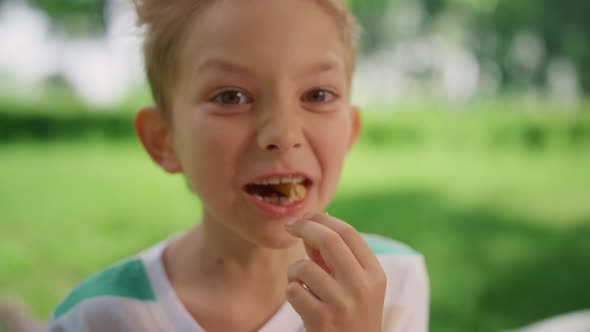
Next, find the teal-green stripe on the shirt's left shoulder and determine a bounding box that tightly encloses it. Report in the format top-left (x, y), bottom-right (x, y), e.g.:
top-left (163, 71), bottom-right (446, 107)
top-left (54, 259), bottom-right (156, 318)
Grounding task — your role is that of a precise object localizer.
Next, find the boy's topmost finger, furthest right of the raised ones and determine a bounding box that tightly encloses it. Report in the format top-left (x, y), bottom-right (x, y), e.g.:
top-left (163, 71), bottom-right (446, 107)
top-left (310, 214), bottom-right (381, 271)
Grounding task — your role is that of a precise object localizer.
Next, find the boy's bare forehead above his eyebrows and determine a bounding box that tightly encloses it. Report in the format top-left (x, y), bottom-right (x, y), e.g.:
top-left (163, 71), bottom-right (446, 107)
top-left (181, 0), bottom-right (347, 80)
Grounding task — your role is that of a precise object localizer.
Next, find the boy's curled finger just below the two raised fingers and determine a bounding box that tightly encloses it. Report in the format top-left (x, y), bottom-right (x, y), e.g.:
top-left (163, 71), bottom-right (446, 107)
top-left (287, 259), bottom-right (340, 303)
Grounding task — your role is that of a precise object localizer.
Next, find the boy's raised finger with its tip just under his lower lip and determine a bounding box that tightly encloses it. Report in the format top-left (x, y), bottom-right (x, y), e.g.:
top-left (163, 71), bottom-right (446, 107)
top-left (287, 219), bottom-right (362, 279)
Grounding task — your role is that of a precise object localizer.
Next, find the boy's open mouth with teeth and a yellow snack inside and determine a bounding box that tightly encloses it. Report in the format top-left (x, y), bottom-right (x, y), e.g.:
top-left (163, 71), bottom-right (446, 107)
top-left (244, 175), bottom-right (312, 206)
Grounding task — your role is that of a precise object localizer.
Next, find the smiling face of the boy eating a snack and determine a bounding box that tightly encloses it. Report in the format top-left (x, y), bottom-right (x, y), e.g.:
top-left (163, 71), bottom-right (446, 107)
top-left (147, 0), bottom-right (359, 248)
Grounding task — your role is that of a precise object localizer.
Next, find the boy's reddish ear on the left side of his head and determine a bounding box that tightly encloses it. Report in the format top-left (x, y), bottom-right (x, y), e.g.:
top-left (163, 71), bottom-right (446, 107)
top-left (134, 107), bottom-right (182, 174)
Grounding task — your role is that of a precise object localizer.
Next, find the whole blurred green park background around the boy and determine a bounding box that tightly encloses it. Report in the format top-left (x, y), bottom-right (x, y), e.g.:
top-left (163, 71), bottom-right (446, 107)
top-left (0, 0), bottom-right (590, 332)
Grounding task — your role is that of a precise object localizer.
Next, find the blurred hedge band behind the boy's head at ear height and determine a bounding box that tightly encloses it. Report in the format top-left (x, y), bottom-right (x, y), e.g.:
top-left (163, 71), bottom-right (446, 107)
top-left (0, 99), bottom-right (590, 151)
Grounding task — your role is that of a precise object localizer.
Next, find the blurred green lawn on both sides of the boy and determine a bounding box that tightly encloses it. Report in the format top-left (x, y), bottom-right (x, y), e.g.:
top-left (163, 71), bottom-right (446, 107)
top-left (0, 112), bottom-right (590, 332)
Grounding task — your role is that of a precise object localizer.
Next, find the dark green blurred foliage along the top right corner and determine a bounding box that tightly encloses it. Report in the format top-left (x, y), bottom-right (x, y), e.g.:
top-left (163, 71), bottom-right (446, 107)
top-left (348, 0), bottom-right (590, 92)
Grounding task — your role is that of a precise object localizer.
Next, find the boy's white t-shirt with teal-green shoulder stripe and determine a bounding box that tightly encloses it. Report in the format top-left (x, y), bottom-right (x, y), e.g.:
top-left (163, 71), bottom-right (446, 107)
top-left (46, 234), bottom-right (429, 332)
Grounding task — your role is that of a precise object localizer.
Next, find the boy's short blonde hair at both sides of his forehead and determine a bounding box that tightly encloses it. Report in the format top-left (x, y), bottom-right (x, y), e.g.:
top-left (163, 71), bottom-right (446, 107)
top-left (132, 0), bottom-right (359, 114)
